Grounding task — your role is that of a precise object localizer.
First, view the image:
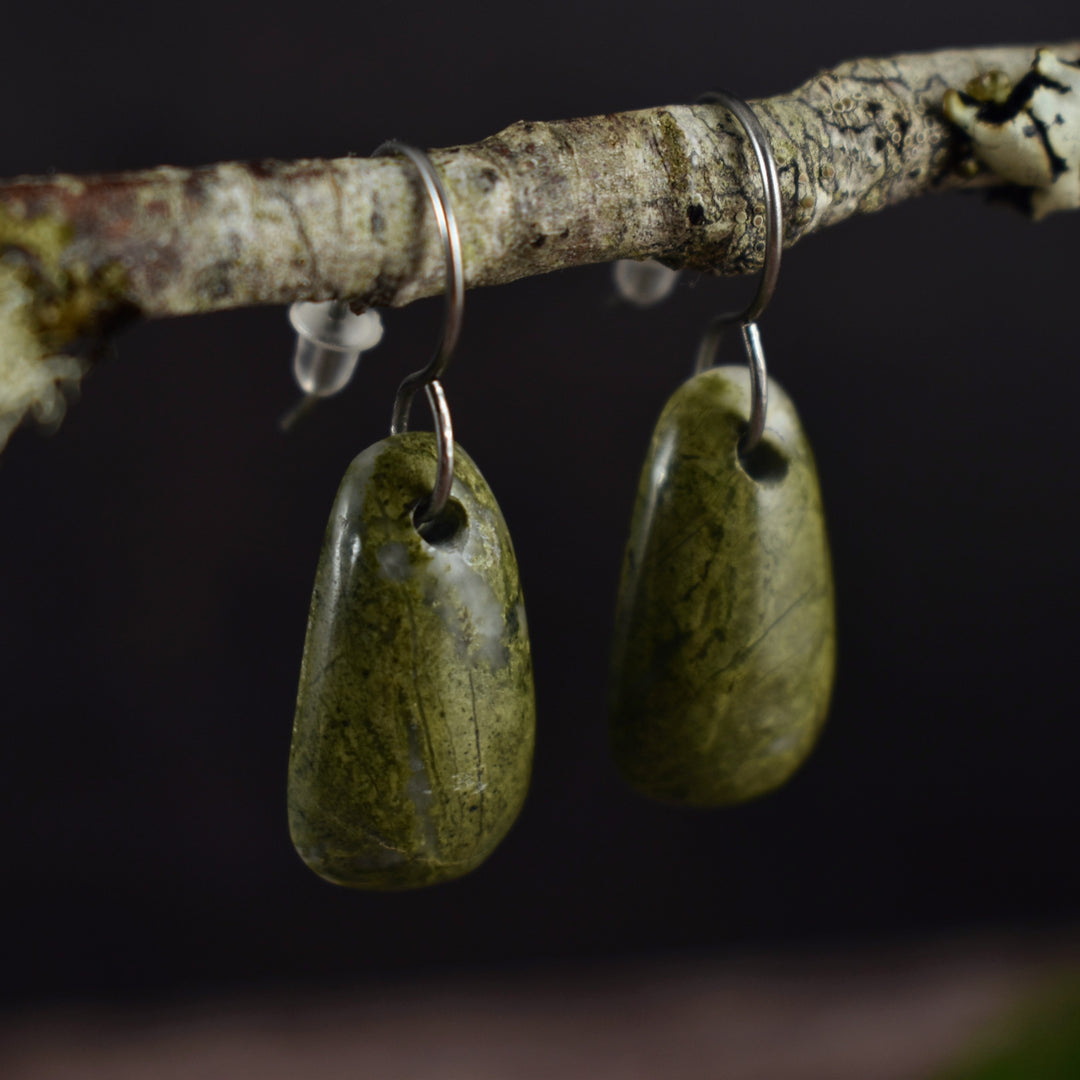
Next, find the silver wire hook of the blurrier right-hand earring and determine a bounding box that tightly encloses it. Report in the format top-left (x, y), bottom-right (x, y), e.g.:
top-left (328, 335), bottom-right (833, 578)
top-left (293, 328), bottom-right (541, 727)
top-left (694, 90), bottom-right (784, 454)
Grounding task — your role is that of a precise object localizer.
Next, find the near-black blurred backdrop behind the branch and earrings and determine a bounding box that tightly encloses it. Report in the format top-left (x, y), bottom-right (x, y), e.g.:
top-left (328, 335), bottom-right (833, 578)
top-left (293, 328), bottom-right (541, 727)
top-left (0, 0), bottom-right (1080, 1004)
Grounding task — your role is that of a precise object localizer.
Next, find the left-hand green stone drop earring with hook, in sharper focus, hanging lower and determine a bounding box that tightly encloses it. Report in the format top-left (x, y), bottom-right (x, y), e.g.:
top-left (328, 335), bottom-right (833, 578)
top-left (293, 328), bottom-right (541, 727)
top-left (288, 143), bottom-right (536, 889)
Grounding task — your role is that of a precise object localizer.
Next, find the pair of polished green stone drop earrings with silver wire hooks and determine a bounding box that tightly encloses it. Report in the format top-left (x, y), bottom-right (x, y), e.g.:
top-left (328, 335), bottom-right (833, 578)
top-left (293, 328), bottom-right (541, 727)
top-left (288, 94), bottom-right (835, 889)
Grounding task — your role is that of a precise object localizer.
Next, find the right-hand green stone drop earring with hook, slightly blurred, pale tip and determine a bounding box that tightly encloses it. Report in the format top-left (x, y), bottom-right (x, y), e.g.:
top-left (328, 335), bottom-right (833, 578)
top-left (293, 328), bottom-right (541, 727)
top-left (610, 93), bottom-right (836, 806)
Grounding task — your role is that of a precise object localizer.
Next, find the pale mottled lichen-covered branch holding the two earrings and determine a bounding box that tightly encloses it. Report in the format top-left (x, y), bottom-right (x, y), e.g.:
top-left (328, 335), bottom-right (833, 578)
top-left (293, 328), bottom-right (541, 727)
top-left (0, 36), bottom-right (1080, 446)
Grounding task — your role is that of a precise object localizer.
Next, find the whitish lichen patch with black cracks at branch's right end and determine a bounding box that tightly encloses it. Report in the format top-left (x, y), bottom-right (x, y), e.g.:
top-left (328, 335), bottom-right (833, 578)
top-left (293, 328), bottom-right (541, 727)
top-left (943, 49), bottom-right (1080, 220)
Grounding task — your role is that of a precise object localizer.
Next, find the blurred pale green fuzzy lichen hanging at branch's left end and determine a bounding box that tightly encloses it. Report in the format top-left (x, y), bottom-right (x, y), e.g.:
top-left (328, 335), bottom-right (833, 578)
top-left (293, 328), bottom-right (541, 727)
top-left (0, 262), bottom-right (83, 450)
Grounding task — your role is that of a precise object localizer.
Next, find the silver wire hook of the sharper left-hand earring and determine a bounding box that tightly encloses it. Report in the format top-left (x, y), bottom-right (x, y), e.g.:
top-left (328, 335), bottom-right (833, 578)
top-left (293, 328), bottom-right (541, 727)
top-left (372, 139), bottom-right (465, 525)
